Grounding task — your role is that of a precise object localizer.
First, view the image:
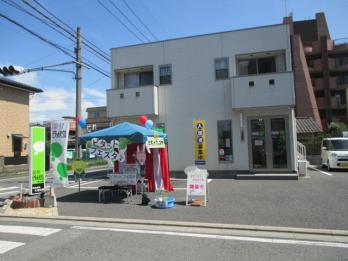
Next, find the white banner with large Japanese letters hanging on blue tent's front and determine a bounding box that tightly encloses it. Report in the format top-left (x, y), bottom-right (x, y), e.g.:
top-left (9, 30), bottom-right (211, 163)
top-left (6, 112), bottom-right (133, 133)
top-left (87, 138), bottom-right (129, 162)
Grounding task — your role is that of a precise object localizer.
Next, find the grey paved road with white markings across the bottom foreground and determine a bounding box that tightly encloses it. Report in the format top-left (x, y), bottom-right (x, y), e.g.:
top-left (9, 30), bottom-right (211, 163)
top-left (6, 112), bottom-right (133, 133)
top-left (0, 216), bottom-right (348, 261)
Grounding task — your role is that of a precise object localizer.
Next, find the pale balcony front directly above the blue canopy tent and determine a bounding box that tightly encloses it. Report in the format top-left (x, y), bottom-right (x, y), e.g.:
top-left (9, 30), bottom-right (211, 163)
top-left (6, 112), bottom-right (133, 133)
top-left (107, 85), bottom-right (158, 118)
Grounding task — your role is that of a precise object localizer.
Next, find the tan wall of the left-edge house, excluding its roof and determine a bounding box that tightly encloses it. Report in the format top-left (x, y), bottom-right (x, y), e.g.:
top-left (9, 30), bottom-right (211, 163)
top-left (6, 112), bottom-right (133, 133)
top-left (0, 85), bottom-right (29, 157)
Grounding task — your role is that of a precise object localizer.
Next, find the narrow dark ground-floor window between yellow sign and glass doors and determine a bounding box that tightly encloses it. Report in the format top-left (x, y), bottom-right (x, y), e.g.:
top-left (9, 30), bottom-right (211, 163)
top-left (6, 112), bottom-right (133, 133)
top-left (217, 120), bottom-right (233, 162)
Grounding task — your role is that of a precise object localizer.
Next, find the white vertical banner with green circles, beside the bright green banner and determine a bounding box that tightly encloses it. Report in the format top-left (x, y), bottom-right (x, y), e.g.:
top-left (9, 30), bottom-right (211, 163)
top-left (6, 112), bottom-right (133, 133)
top-left (51, 121), bottom-right (70, 187)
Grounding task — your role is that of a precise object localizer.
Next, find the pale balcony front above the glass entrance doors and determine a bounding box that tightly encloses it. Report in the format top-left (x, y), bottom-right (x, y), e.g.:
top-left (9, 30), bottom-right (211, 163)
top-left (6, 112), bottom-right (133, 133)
top-left (231, 72), bottom-right (295, 109)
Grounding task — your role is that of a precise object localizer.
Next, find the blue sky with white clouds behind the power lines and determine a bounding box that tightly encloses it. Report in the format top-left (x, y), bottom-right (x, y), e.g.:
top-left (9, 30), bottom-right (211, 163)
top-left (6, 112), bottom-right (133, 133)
top-left (0, 0), bottom-right (348, 122)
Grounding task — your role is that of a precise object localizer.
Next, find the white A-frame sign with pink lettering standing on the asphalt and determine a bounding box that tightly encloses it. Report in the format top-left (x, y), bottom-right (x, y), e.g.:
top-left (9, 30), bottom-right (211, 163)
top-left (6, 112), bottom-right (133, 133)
top-left (185, 166), bottom-right (208, 206)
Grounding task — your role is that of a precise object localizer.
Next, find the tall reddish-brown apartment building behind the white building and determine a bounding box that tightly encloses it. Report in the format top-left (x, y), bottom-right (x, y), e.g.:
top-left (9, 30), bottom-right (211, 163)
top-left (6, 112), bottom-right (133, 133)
top-left (283, 13), bottom-right (348, 130)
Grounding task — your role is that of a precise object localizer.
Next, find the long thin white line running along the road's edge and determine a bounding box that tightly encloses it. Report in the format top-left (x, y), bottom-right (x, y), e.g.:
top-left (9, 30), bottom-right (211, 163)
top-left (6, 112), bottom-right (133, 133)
top-left (71, 226), bottom-right (348, 248)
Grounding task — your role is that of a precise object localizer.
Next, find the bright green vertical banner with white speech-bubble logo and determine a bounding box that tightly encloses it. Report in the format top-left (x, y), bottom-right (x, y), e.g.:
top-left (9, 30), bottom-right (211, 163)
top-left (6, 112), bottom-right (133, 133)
top-left (29, 127), bottom-right (45, 194)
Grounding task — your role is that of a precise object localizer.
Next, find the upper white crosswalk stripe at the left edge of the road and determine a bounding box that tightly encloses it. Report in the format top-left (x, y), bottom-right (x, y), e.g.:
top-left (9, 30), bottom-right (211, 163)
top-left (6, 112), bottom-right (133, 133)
top-left (0, 225), bottom-right (61, 237)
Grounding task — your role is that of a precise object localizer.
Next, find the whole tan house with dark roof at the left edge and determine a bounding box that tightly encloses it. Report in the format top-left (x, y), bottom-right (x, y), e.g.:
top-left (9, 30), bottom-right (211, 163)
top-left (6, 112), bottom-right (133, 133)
top-left (0, 78), bottom-right (42, 173)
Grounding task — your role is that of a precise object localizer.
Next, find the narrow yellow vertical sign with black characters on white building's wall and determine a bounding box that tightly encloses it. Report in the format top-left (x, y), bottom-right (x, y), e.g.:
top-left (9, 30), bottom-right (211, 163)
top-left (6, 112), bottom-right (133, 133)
top-left (193, 120), bottom-right (207, 165)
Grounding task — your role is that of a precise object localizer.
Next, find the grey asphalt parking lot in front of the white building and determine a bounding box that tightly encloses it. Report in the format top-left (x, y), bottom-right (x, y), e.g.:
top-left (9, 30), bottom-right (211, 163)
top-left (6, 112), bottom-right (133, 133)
top-left (56, 168), bottom-right (348, 230)
